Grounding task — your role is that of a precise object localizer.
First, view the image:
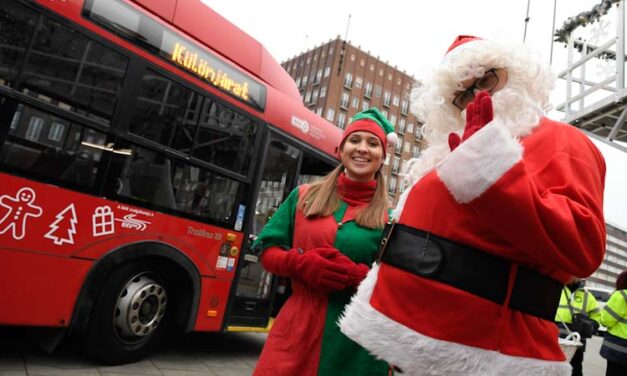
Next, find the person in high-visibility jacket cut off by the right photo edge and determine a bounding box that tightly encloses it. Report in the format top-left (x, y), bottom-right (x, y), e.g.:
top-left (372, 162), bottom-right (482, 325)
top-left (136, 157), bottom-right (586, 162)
top-left (601, 270), bottom-right (627, 376)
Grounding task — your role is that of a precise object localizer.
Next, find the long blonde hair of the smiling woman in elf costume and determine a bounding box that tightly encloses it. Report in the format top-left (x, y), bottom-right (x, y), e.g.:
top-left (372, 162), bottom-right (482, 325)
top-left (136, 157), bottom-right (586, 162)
top-left (298, 165), bottom-right (388, 229)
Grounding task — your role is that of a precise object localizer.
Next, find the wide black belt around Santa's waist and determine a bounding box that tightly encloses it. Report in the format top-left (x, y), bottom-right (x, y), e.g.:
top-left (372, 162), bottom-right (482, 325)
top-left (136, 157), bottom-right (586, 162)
top-left (379, 223), bottom-right (563, 321)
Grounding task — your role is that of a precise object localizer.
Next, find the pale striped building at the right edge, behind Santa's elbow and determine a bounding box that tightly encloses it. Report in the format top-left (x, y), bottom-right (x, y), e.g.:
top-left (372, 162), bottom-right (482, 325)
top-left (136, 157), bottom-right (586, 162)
top-left (586, 224), bottom-right (627, 290)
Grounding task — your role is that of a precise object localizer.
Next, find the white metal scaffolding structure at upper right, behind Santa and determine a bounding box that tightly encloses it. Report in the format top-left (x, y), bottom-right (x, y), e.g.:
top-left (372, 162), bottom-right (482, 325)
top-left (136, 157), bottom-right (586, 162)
top-left (556, 1), bottom-right (627, 152)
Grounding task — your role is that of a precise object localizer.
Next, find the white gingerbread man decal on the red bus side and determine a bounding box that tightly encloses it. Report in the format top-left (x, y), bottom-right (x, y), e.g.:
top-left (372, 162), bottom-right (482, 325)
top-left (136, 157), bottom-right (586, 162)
top-left (0, 187), bottom-right (42, 240)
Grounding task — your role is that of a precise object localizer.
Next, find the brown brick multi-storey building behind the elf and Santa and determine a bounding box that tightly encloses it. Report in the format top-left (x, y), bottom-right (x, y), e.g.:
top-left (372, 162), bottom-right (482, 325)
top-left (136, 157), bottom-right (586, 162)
top-left (281, 37), bottom-right (423, 204)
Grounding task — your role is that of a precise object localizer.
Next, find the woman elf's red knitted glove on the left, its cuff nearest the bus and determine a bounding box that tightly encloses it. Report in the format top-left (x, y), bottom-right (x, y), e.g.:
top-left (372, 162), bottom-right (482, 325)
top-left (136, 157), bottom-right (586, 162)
top-left (261, 247), bottom-right (350, 291)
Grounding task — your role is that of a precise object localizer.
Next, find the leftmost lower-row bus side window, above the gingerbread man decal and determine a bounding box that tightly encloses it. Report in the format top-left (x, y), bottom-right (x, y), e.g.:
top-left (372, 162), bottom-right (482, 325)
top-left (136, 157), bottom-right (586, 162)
top-left (0, 99), bottom-right (106, 188)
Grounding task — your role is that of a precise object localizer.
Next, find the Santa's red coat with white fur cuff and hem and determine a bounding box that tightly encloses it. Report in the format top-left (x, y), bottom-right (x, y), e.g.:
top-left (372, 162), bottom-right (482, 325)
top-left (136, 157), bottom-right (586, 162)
top-left (340, 119), bottom-right (605, 375)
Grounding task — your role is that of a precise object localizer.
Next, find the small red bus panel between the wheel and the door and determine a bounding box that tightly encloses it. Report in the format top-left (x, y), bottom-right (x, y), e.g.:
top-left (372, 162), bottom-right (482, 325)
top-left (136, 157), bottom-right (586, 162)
top-left (194, 278), bottom-right (231, 332)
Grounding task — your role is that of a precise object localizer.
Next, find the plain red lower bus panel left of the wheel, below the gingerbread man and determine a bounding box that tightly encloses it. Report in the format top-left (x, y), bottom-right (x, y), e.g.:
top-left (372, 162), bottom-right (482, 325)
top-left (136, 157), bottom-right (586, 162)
top-left (0, 249), bottom-right (92, 327)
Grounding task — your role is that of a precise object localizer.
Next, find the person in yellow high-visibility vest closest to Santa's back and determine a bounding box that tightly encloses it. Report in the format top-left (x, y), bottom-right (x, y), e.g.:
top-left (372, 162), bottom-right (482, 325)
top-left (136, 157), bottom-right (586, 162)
top-left (555, 279), bottom-right (601, 376)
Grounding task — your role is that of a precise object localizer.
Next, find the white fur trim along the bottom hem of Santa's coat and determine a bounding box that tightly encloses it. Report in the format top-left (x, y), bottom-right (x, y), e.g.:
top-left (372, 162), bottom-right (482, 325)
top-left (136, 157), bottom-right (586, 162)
top-left (338, 264), bottom-right (571, 376)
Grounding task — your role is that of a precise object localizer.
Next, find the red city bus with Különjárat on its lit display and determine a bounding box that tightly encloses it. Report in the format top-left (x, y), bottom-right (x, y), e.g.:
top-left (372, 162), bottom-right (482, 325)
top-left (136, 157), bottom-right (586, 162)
top-left (0, 0), bottom-right (340, 364)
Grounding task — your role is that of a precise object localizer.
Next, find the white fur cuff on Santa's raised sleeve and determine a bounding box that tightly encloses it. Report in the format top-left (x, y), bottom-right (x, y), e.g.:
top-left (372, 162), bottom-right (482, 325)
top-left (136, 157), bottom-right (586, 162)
top-left (436, 120), bottom-right (523, 204)
